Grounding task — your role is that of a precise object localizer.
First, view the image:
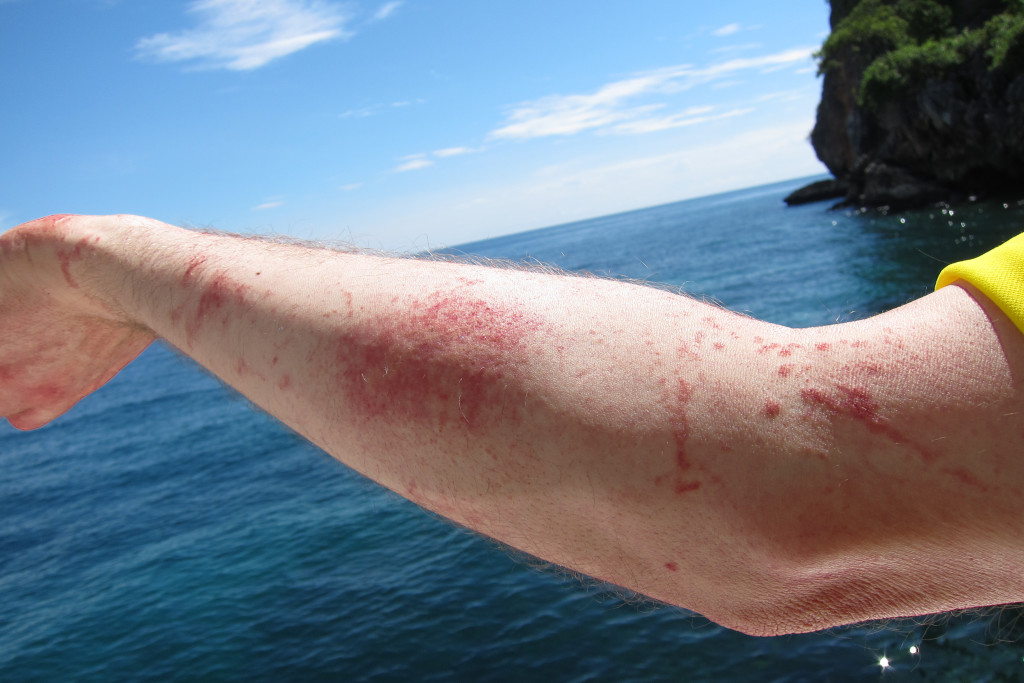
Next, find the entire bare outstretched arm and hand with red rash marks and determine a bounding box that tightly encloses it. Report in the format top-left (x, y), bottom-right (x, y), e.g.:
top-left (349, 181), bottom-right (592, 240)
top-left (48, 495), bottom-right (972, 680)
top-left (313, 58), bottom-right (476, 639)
top-left (0, 216), bottom-right (1024, 635)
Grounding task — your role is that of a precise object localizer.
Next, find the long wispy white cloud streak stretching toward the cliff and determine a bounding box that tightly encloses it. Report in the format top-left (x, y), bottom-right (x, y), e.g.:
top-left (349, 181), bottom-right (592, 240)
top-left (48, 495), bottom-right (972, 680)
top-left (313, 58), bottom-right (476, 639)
top-left (489, 47), bottom-right (815, 139)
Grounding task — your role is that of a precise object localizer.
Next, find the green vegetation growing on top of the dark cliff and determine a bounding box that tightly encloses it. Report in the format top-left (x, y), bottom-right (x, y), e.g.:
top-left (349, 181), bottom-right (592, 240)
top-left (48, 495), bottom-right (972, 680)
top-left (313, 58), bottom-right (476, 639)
top-left (818, 0), bottom-right (1024, 111)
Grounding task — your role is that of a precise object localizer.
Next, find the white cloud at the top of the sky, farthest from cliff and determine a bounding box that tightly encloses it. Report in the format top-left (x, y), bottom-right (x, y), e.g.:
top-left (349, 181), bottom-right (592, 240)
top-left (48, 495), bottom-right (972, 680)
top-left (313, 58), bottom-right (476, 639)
top-left (135, 0), bottom-right (351, 71)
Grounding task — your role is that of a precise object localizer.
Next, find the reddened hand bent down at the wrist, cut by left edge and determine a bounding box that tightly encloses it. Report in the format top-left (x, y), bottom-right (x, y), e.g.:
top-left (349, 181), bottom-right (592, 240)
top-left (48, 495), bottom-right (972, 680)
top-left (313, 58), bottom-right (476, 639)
top-left (0, 216), bottom-right (154, 429)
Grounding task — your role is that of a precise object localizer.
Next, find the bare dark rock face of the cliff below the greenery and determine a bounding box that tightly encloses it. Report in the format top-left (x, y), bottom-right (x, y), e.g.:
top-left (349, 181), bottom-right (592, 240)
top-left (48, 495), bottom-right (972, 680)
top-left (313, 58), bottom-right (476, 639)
top-left (811, 0), bottom-right (1024, 209)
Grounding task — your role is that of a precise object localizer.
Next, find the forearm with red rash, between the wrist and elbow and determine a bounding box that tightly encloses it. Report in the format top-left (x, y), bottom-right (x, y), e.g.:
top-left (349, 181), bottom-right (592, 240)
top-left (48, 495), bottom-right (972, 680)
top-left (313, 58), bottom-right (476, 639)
top-left (64, 218), bottom-right (793, 621)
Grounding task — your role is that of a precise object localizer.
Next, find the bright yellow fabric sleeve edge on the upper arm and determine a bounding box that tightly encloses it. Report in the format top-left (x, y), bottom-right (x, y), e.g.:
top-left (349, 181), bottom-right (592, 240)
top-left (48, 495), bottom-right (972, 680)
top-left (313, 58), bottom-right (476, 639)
top-left (935, 233), bottom-right (1024, 332)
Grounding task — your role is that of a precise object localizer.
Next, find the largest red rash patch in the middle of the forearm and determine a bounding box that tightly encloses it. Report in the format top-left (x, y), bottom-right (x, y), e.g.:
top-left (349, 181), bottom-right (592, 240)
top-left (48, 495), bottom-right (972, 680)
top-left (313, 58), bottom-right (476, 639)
top-left (334, 293), bottom-right (541, 429)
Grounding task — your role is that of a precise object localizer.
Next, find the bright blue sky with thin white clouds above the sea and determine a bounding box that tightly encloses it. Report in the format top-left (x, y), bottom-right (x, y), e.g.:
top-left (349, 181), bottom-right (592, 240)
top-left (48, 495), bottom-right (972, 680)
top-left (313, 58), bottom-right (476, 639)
top-left (0, 0), bottom-right (828, 251)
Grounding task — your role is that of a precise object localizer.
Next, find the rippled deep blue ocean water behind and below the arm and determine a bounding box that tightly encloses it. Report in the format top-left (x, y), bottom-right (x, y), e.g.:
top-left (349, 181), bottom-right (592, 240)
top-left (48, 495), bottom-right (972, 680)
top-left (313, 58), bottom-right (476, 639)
top-left (0, 180), bottom-right (1024, 681)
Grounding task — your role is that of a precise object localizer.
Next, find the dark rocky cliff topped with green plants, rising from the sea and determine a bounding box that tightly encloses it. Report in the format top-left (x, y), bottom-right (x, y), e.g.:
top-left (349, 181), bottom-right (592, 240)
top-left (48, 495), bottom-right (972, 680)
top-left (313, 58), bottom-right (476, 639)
top-left (790, 0), bottom-right (1024, 208)
